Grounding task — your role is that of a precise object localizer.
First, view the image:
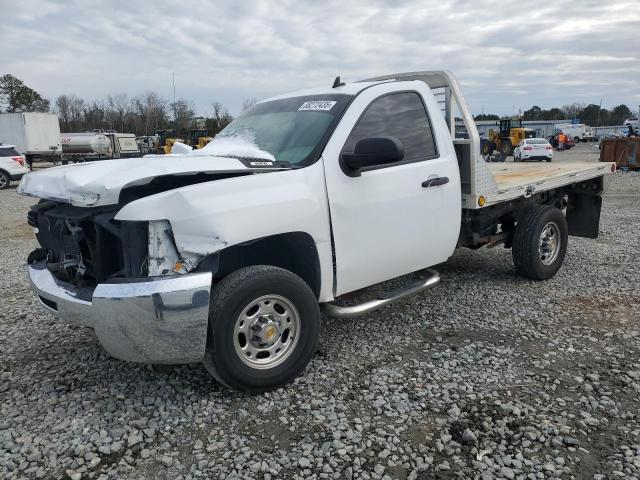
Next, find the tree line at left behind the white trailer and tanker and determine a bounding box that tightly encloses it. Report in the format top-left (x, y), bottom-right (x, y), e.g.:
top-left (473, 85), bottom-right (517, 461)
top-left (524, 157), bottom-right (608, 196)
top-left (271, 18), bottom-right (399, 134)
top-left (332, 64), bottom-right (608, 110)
top-left (0, 74), bottom-right (256, 139)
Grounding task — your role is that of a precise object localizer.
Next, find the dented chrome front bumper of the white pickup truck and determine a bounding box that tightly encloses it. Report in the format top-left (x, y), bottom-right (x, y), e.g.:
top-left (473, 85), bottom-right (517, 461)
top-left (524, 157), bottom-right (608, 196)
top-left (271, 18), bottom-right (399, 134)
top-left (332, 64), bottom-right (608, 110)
top-left (29, 261), bottom-right (211, 363)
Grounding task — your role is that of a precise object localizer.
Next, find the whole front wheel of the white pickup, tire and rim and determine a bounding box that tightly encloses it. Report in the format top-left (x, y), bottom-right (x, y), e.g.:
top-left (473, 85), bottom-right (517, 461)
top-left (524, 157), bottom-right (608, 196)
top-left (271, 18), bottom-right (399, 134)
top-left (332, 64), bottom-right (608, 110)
top-left (204, 265), bottom-right (320, 392)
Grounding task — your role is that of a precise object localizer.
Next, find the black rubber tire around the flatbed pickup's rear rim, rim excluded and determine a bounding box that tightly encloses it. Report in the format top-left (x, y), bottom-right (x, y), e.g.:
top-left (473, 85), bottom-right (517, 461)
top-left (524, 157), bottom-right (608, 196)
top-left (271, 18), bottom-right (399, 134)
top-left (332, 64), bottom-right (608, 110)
top-left (511, 205), bottom-right (568, 280)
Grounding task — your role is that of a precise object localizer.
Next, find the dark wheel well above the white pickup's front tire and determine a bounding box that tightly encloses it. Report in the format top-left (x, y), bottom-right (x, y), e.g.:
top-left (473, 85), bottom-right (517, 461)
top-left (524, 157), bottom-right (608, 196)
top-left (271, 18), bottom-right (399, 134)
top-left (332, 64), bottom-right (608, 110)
top-left (198, 232), bottom-right (321, 297)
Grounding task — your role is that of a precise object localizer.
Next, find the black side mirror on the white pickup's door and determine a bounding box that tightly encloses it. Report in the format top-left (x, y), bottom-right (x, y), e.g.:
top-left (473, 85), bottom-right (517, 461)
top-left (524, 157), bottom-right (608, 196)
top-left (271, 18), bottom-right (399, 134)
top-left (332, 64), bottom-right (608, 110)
top-left (340, 137), bottom-right (404, 177)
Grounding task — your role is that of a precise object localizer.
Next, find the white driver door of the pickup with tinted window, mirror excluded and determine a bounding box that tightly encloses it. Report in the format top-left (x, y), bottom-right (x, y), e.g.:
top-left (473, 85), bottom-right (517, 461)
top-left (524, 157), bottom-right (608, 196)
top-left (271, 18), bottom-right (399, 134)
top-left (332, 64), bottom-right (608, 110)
top-left (323, 82), bottom-right (461, 296)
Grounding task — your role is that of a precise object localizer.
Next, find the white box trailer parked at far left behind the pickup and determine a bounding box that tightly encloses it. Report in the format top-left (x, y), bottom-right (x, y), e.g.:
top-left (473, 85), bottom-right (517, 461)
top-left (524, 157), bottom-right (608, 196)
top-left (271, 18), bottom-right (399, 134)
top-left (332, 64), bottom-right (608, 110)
top-left (0, 112), bottom-right (62, 164)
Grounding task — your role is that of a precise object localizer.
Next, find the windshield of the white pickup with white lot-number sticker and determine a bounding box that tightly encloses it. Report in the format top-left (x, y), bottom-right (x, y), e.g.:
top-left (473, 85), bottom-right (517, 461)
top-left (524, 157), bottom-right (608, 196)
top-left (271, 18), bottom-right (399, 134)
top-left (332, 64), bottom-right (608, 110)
top-left (200, 95), bottom-right (352, 165)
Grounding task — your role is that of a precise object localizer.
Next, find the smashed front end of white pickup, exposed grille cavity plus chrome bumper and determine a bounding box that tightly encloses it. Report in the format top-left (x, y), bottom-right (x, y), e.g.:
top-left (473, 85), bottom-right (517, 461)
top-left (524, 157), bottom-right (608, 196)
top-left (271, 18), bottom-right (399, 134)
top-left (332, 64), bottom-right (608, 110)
top-left (28, 201), bottom-right (212, 363)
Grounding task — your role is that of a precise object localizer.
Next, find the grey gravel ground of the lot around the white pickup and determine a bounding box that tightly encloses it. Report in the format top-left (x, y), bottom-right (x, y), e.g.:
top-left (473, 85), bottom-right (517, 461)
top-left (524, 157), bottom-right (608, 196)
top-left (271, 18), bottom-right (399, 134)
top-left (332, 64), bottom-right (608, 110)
top-left (0, 147), bottom-right (640, 479)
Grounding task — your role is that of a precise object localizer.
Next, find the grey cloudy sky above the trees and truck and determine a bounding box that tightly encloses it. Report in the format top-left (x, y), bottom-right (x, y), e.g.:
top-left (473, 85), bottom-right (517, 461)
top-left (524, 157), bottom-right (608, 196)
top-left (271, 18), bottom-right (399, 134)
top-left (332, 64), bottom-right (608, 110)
top-left (0, 0), bottom-right (640, 115)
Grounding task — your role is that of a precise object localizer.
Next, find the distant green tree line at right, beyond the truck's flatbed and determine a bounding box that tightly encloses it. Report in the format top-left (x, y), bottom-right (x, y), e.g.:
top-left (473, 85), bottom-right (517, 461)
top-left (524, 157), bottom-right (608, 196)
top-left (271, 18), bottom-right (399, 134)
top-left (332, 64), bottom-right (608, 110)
top-left (474, 103), bottom-right (637, 127)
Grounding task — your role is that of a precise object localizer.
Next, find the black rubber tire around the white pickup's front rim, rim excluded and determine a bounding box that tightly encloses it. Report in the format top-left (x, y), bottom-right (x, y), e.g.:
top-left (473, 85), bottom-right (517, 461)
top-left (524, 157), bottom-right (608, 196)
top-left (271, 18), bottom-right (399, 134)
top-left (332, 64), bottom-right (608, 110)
top-left (204, 265), bottom-right (320, 392)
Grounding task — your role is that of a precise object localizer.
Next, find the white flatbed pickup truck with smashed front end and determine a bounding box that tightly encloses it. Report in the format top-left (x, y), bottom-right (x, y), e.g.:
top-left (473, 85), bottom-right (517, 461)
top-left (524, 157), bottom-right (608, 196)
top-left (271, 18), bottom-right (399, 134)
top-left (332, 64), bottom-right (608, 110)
top-left (19, 71), bottom-right (615, 391)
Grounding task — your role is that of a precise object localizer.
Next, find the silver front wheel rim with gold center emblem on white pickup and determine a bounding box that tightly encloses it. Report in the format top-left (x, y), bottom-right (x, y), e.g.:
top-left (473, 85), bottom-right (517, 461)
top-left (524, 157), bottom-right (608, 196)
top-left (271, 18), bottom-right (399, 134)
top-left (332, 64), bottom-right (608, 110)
top-left (233, 295), bottom-right (300, 369)
